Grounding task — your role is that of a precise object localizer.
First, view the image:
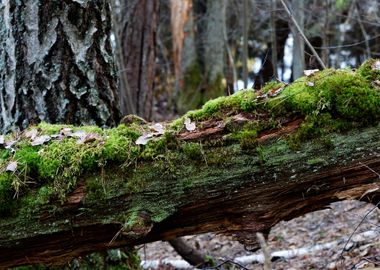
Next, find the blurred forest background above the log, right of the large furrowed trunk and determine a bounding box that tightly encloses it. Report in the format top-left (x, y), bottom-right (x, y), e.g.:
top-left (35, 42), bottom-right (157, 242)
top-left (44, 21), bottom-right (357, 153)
top-left (113, 0), bottom-right (380, 121)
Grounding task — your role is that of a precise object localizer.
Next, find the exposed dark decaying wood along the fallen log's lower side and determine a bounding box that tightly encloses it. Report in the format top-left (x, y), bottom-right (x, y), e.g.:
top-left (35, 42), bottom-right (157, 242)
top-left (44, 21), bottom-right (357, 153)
top-left (0, 117), bottom-right (380, 267)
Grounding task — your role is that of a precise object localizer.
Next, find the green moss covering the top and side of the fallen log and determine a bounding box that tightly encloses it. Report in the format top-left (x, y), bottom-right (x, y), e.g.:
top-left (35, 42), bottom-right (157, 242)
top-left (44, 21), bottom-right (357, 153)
top-left (0, 60), bottom-right (380, 266)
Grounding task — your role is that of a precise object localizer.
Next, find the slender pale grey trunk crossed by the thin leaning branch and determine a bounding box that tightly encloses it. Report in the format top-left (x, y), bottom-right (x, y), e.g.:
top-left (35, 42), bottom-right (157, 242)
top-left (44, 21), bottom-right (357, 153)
top-left (290, 0), bottom-right (305, 80)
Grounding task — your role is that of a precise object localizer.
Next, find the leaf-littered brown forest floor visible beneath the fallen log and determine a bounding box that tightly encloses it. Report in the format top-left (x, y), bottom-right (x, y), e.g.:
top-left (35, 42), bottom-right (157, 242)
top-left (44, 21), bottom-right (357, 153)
top-left (139, 201), bottom-right (380, 270)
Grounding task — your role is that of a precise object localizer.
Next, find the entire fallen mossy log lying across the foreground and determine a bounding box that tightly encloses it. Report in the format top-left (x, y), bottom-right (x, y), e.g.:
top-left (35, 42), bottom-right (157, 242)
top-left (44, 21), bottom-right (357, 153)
top-left (0, 60), bottom-right (380, 267)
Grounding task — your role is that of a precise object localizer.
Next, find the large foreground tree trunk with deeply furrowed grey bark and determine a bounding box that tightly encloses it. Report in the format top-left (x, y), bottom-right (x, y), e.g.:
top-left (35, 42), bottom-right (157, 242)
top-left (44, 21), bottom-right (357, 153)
top-left (0, 0), bottom-right (120, 132)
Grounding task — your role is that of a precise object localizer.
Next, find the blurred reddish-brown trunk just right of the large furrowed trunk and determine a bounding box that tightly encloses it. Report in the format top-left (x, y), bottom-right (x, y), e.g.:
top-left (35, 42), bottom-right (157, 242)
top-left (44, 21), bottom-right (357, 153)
top-left (116, 0), bottom-right (158, 120)
